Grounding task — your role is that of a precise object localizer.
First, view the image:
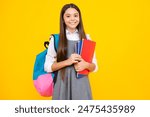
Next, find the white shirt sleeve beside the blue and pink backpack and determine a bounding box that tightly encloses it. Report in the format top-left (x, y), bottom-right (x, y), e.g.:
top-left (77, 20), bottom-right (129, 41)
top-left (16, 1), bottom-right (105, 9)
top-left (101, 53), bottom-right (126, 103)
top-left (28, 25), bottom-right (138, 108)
top-left (44, 36), bottom-right (56, 72)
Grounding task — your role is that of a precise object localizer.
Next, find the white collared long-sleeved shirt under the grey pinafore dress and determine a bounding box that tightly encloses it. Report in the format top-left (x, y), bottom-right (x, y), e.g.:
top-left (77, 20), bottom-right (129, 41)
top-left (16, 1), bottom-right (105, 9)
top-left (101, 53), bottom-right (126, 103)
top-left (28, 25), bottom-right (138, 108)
top-left (44, 29), bottom-right (98, 72)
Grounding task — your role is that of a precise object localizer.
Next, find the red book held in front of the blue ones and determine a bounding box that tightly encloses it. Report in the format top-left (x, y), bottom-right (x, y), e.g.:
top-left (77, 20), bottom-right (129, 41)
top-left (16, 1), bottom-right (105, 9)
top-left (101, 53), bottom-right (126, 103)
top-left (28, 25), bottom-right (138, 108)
top-left (77, 39), bottom-right (96, 77)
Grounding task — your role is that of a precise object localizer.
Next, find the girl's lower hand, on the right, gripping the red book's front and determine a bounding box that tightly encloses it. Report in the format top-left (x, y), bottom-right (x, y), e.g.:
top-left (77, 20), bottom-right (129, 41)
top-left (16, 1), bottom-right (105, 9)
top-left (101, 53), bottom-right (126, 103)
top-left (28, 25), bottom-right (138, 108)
top-left (74, 59), bottom-right (89, 71)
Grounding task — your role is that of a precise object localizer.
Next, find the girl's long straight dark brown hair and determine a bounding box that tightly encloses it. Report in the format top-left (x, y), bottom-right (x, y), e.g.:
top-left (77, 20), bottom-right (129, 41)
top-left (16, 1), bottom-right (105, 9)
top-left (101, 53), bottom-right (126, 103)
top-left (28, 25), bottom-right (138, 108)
top-left (57, 3), bottom-right (86, 79)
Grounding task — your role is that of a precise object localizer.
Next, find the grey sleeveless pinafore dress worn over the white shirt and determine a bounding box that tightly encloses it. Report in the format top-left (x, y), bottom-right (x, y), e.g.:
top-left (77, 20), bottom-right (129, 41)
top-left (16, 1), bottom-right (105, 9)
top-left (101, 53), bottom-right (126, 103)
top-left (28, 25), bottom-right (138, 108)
top-left (52, 40), bottom-right (92, 100)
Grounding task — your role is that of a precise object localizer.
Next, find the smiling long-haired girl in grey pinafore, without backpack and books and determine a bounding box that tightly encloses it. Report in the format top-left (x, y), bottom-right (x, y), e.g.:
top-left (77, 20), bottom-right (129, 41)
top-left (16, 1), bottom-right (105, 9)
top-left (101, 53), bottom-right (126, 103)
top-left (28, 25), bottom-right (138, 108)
top-left (44, 4), bottom-right (97, 100)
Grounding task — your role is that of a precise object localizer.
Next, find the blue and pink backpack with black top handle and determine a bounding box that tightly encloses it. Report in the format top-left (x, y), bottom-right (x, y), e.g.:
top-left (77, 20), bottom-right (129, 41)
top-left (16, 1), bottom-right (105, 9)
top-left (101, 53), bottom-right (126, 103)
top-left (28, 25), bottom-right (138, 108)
top-left (33, 34), bottom-right (59, 97)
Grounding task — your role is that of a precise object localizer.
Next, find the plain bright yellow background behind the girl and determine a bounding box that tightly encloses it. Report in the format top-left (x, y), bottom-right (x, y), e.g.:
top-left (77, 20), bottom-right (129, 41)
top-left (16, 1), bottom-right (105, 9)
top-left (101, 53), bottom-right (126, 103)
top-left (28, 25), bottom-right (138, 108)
top-left (0, 0), bottom-right (150, 99)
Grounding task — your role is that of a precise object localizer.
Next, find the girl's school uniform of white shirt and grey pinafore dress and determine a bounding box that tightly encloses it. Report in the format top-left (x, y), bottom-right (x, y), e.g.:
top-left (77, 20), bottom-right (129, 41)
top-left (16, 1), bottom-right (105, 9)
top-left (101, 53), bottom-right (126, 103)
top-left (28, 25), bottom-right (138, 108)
top-left (44, 29), bottom-right (98, 100)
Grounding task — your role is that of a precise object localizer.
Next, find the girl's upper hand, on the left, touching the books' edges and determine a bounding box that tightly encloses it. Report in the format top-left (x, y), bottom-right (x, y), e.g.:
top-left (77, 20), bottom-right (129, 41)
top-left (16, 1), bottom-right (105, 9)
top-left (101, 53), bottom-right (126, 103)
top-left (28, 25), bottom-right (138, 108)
top-left (66, 54), bottom-right (82, 66)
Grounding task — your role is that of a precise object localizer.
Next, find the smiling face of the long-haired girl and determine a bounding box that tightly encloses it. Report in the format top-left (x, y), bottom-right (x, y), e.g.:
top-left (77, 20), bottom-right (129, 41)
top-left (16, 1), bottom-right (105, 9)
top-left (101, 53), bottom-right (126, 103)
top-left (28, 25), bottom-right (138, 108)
top-left (63, 8), bottom-right (80, 32)
